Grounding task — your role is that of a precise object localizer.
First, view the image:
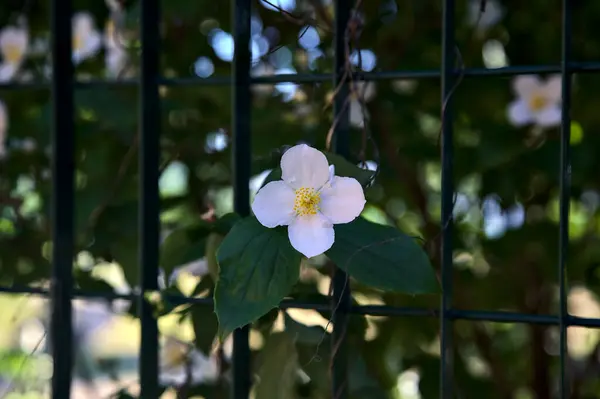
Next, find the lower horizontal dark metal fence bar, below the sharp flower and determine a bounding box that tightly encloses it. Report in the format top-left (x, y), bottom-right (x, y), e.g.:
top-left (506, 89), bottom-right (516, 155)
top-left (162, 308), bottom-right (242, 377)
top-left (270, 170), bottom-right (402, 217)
top-left (0, 286), bottom-right (600, 328)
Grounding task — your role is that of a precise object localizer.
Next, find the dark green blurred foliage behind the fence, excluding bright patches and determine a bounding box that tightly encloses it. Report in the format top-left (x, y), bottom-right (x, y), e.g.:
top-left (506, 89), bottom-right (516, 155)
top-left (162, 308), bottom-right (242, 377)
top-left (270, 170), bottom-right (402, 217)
top-left (0, 0), bottom-right (600, 399)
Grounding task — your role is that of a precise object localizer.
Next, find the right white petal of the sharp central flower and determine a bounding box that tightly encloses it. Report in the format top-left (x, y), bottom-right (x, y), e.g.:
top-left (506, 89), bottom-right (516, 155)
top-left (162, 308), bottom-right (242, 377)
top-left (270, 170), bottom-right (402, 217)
top-left (320, 176), bottom-right (366, 224)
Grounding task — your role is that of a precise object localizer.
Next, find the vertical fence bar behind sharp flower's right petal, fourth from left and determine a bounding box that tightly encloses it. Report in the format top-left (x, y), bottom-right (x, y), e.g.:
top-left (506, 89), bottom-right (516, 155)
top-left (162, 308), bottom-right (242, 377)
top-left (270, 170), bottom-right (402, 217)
top-left (331, 0), bottom-right (354, 399)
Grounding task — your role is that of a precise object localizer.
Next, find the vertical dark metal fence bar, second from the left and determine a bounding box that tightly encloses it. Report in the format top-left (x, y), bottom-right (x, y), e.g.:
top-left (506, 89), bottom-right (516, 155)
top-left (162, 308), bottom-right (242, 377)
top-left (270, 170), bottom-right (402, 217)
top-left (138, 0), bottom-right (161, 399)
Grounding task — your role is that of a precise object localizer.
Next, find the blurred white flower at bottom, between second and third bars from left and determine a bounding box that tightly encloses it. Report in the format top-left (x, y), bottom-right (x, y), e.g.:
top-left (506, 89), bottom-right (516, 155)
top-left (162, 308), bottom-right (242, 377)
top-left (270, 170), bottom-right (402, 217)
top-left (158, 337), bottom-right (219, 387)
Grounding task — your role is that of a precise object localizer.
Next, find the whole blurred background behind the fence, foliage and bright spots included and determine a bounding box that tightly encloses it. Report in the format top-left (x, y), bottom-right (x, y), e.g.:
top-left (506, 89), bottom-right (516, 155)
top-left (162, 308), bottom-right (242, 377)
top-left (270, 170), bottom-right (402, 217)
top-left (0, 0), bottom-right (600, 399)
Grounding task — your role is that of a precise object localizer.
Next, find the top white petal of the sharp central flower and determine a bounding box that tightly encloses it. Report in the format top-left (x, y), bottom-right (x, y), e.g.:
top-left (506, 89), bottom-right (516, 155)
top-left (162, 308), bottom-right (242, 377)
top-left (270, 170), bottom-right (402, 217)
top-left (281, 144), bottom-right (329, 189)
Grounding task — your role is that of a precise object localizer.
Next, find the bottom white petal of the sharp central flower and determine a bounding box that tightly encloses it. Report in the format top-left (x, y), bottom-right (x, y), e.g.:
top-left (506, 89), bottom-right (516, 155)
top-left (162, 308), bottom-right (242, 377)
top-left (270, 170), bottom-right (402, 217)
top-left (288, 214), bottom-right (335, 258)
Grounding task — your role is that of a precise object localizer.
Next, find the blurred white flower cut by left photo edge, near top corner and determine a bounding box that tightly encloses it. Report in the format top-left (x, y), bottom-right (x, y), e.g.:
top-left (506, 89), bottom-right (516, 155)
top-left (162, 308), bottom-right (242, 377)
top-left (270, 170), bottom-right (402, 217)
top-left (0, 26), bottom-right (29, 82)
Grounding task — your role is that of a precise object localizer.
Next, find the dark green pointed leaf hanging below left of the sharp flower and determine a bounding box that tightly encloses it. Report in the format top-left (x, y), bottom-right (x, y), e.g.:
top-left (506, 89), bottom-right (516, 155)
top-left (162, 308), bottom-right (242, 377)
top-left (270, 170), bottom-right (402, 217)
top-left (214, 217), bottom-right (301, 338)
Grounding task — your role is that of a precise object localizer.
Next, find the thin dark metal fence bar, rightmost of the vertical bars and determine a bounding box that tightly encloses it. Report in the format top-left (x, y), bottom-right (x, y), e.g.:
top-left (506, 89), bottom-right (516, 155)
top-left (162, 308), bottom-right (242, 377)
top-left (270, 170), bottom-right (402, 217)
top-left (558, 0), bottom-right (572, 398)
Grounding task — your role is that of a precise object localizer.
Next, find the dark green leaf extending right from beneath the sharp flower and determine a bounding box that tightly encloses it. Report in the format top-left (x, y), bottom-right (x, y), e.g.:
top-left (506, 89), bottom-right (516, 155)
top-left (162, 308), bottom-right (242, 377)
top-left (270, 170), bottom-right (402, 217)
top-left (327, 217), bottom-right (438, 294)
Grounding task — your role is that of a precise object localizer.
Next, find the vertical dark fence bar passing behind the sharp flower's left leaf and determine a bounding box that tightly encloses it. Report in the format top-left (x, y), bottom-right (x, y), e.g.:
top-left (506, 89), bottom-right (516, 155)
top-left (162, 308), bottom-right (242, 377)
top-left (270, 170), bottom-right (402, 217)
top-left (232, 0), bottom-right (251, 399)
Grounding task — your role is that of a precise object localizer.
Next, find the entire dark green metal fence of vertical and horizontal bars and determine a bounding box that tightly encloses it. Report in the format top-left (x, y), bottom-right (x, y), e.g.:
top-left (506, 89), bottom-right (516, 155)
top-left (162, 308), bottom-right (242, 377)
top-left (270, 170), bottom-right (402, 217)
top-left (0, 0), bottom-right (600, 399)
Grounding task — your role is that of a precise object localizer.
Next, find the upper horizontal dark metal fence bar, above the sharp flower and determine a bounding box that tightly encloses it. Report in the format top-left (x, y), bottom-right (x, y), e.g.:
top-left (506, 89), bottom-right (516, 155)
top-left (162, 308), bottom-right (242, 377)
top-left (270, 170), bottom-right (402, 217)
top-left (0, 62), bottom-right (600, 90)
